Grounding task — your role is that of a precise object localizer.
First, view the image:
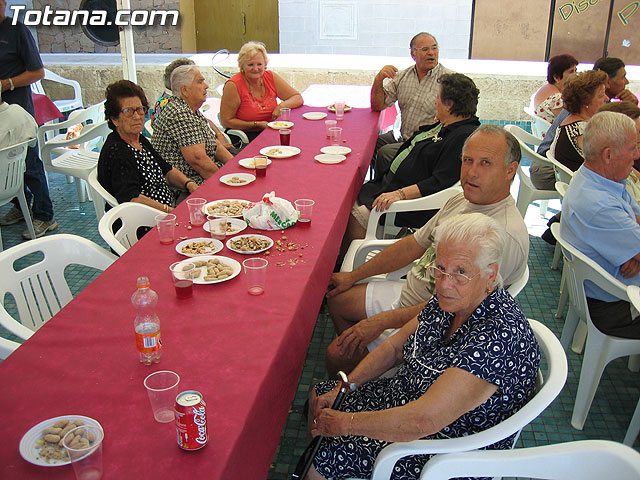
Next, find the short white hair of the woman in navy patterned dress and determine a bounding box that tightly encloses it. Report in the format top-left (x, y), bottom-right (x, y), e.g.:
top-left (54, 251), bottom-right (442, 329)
top-left (433, 213), bottom-right (507, 287)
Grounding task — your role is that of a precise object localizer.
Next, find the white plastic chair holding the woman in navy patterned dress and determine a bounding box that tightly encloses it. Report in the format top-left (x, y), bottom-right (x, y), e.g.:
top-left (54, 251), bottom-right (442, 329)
top-left (348, 319), bottom-right (567, 480)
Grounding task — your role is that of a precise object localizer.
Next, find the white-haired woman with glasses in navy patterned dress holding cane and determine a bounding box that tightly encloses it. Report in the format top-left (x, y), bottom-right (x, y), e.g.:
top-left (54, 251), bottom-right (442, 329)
top-left (307, 213), bottom-right (540, 480)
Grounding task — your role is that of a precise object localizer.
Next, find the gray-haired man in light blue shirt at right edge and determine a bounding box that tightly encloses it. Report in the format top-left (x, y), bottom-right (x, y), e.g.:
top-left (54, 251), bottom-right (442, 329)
top-left (560, 112), bottom-right (640, 338)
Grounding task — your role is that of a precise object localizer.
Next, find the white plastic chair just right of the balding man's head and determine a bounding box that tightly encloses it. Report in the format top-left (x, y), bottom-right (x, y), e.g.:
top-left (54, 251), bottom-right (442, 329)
top-left (504, 125), bottom-right (559, 218)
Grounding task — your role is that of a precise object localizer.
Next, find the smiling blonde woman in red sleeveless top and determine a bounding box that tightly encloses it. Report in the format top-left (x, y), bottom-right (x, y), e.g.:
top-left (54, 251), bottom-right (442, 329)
top-left (220, 42), bottom-right (302, 140)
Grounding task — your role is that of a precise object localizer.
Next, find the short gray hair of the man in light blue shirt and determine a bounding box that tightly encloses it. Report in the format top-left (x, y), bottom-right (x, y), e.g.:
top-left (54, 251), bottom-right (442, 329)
top-left (582, 112), bottom-right (636, 162)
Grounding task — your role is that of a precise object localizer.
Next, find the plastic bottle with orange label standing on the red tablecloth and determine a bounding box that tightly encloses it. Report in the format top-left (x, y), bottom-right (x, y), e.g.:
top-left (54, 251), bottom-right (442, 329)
top-left (131, 277), bottom-right (162, 365)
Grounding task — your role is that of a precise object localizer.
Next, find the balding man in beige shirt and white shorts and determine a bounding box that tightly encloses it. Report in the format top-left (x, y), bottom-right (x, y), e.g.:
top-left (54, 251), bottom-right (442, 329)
top-left (327, 124), bottom-right (529, 376)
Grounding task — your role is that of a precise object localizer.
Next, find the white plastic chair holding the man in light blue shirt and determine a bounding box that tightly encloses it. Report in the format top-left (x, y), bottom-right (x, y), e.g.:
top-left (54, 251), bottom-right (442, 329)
top-left (551, 223), bottom-right (640, 430)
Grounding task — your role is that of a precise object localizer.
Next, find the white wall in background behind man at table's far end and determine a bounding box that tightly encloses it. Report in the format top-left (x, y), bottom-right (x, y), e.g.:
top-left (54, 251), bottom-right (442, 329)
top-left (279, 0), bottom-right (472, 58)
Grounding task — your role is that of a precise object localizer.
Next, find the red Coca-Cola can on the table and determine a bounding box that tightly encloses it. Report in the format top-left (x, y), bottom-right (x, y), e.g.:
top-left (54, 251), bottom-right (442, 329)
top-left (174, 390), bottom-right (209, 450)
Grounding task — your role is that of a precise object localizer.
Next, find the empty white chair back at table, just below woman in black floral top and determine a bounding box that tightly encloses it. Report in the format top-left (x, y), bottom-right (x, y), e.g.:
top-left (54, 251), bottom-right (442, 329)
top-left (98, 202), bottom-right (162, 255)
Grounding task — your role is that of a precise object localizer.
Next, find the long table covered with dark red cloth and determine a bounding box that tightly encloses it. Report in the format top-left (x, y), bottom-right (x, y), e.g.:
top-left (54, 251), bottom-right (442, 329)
top-left (0, 88), bottom-right (379, 480)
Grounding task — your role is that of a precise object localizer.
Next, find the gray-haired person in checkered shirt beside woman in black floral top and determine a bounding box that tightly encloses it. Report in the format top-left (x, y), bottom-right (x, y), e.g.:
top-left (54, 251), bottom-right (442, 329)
top-left (151, 65), bottom-right (233, 185)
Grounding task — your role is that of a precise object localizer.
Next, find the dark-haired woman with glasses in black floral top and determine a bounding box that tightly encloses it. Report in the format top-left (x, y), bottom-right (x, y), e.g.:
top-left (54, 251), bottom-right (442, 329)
top-left (98, 80), bottom-right (198, 212)
